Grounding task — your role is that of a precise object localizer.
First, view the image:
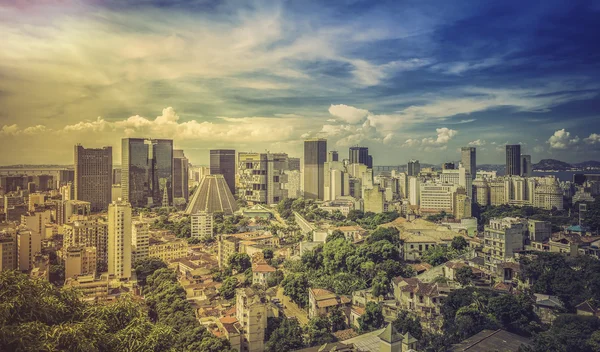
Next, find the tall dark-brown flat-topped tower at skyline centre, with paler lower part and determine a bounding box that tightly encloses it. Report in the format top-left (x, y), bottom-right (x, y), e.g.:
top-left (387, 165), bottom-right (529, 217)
top-left (304, 138), bottom-right (327, 200)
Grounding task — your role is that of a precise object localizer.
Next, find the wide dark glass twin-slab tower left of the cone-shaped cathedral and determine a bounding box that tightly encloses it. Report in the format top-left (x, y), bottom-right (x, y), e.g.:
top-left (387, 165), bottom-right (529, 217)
top-left (121, 138), bottom-right (173, 207)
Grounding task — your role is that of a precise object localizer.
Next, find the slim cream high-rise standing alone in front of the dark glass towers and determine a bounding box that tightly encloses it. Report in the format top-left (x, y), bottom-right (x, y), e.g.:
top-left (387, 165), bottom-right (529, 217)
top-left (108, 201), bottom-right (132, 279)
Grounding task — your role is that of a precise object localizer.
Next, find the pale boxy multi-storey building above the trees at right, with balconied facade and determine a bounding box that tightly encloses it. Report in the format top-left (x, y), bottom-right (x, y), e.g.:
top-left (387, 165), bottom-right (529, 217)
top-left (483, 218), bottom-right (527, 272)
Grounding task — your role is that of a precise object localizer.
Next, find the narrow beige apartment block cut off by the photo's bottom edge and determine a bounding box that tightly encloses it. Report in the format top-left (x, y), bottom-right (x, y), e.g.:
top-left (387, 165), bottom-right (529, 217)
top-left (235, 288), bottom-right (268, 352)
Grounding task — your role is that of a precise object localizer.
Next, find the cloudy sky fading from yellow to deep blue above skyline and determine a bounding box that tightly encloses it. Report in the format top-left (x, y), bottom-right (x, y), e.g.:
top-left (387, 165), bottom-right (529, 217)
top-left (0, 0), bottom-right (600, 165)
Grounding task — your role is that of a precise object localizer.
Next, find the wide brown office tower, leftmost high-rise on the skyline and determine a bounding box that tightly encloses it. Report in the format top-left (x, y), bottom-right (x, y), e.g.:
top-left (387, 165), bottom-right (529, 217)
top-left (75, 144), bottom-right (112, 211)
